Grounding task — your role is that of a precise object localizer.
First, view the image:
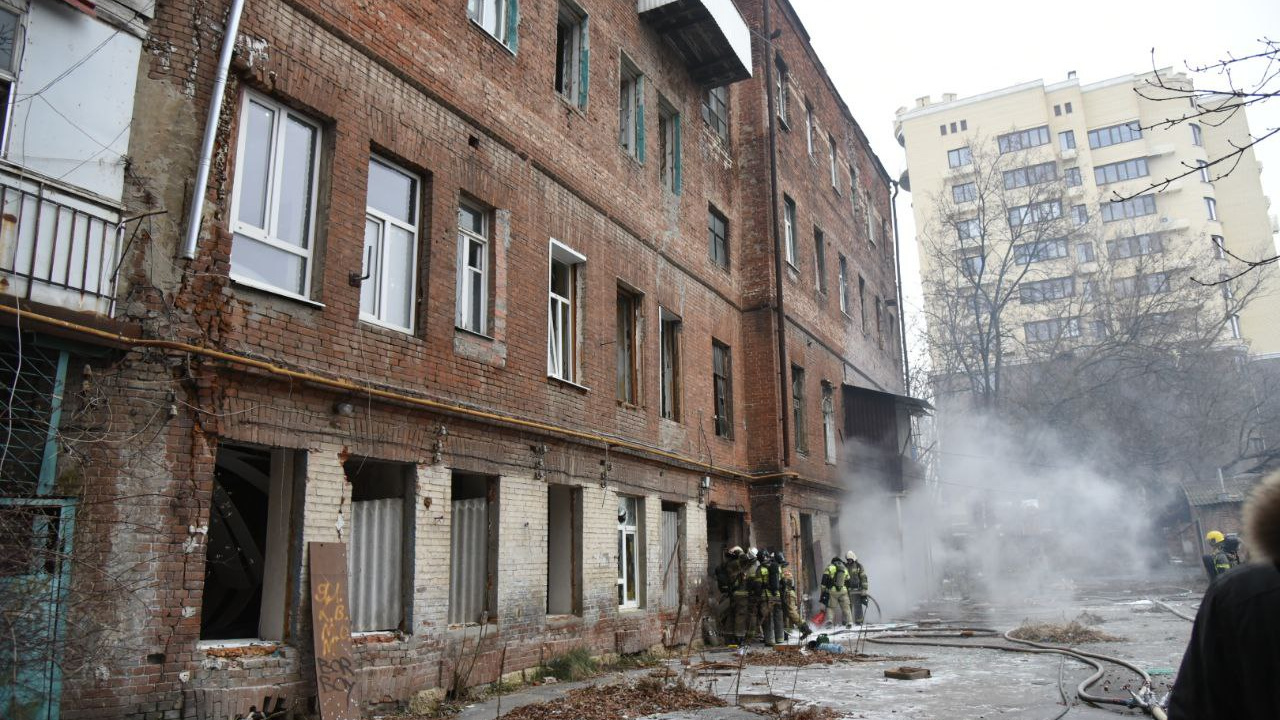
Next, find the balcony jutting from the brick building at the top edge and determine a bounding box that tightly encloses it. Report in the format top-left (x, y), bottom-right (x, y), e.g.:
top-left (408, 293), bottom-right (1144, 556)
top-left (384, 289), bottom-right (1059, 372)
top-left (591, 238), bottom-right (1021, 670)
top-left (636, 0), bottom-right (751, 87)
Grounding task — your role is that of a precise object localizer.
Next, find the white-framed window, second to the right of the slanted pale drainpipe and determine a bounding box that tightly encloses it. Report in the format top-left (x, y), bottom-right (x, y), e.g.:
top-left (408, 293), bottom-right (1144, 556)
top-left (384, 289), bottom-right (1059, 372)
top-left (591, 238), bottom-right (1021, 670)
top-left (360, 158), bottom-right (419, 332)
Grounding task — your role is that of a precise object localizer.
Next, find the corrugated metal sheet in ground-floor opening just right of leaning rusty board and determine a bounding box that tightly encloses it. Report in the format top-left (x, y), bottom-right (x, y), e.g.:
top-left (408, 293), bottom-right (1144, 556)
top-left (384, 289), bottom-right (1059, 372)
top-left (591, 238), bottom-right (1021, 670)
top-left (347, 497), bottom-right (404, 633)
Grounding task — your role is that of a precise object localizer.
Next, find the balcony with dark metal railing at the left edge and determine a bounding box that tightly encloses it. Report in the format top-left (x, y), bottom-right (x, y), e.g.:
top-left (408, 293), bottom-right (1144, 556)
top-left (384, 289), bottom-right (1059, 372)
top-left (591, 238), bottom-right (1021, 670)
top-left (0, 164), bottom-right (122, 315)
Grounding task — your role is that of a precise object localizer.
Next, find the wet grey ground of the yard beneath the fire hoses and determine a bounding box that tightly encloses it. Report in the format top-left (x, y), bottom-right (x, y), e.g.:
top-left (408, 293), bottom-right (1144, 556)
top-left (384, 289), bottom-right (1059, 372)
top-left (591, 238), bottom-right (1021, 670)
top-left (450, 571), bottom-right (1204, 720)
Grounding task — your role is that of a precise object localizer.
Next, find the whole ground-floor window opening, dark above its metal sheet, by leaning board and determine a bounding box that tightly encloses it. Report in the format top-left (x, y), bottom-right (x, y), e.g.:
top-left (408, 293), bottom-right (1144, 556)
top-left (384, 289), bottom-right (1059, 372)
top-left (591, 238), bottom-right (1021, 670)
top-left (343, 457), bottom-right (416, 633)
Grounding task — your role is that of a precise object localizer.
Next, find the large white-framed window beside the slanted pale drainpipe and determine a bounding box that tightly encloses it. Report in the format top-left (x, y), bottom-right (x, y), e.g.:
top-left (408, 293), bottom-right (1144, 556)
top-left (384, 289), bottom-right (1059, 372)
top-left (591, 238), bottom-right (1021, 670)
top-left (230, 92), bottom-right (320, 300)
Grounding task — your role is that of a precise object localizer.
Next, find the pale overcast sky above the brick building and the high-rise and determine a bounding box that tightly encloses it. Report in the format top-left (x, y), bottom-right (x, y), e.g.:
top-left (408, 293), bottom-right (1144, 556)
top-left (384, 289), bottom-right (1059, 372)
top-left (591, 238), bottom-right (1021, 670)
top-left (791, 0), bottom-right (1280, 333)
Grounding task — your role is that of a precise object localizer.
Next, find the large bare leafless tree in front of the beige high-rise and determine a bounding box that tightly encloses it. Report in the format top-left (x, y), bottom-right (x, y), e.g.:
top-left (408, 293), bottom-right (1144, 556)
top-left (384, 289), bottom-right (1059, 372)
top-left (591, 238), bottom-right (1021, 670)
top-left (922, 136), bottom-right (1268, 487)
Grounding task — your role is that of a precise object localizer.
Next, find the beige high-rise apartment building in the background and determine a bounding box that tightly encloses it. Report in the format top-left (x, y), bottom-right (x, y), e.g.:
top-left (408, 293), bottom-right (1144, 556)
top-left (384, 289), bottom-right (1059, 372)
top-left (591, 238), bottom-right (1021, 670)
top-left (895, 70), bottom-right (1280, 363)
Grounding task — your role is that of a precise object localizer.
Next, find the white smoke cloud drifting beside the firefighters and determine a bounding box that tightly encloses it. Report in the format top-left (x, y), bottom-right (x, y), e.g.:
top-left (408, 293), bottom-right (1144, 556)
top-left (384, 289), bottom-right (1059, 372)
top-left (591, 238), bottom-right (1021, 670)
top-left (838, 409), bottom-right (1152, 621)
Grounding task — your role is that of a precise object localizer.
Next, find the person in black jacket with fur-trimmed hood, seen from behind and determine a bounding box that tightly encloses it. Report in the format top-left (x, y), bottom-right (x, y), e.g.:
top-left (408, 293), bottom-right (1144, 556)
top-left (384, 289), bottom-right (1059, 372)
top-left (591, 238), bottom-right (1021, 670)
top-left (1169, 473), bottom-right (1280, 720)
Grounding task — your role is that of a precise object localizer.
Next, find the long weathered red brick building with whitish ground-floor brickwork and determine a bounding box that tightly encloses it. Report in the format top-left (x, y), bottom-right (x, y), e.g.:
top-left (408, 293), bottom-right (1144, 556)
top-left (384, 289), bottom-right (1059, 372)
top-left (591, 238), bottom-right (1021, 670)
top-left (4, 0), bottom-right (911, 719)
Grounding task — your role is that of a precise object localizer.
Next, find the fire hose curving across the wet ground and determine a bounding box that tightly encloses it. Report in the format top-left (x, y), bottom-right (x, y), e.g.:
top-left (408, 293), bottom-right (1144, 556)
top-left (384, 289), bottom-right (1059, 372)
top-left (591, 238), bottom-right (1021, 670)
top-left (867, 620), bottom-right (1166, 720)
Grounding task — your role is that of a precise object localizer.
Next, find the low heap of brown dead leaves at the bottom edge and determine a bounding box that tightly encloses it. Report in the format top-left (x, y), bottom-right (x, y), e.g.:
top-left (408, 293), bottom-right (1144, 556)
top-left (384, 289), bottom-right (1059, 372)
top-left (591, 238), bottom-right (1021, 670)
top-left (502, 678), bottom-right (728, 720)
